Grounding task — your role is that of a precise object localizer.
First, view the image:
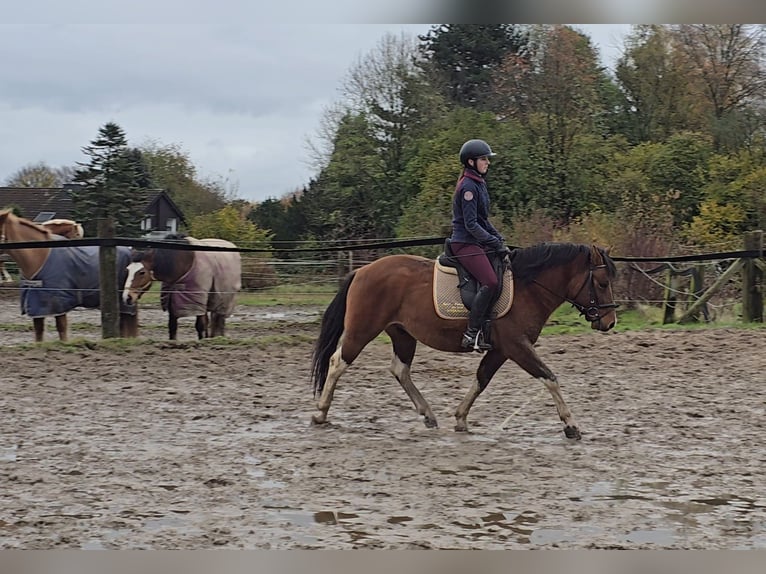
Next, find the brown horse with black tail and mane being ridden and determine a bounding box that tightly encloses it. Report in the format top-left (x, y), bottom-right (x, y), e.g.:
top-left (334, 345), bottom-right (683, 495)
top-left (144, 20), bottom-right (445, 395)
top-left (312, 243), bottom-right (617, 439)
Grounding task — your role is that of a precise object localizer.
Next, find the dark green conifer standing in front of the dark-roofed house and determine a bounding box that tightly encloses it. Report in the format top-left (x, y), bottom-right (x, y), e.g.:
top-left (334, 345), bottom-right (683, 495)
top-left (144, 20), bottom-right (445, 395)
top-left (71, 122), bottom-right (144, 237)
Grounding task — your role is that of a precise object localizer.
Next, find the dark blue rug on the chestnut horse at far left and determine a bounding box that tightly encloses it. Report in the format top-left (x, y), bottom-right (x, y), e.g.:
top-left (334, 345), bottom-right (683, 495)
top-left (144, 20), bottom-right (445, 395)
top-left (19, 246), bottom-right (136, 319)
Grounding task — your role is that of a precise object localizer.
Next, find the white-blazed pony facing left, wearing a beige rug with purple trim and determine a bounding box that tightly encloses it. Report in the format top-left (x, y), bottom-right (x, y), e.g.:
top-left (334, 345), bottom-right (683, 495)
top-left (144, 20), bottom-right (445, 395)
top-left (122, 234), bottom-right (242, 340)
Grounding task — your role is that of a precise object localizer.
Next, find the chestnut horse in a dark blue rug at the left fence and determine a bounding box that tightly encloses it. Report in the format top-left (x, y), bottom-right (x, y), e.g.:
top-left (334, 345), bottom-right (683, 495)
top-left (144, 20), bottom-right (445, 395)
top-left (0, 209), bottom-right (138, 343)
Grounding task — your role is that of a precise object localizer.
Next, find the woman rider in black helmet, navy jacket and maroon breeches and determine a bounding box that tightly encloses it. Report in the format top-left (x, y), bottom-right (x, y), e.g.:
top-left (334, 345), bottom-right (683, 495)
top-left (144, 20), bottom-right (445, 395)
top-left (450, 139), bottom-right (505, 351)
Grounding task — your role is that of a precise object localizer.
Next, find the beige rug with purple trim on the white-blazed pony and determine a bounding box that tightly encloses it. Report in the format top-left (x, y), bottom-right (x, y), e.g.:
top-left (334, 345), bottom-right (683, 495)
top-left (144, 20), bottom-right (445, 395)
top-left (160, 237), bottom-right (242, 317)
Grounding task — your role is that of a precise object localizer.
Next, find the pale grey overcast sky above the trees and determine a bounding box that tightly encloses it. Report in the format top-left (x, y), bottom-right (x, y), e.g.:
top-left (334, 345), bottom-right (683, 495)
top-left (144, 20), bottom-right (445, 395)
top-left (0, 10), bottom-right (629, 201)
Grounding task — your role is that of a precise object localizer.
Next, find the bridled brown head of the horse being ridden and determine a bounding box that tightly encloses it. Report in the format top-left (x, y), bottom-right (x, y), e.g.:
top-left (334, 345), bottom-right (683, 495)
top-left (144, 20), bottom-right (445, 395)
top-left (570, 245), bottom-right (617, 331)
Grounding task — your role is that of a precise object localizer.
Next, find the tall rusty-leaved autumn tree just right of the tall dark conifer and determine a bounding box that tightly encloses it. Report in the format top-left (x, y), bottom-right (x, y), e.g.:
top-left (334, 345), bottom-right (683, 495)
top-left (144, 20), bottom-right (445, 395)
top-left (495, 25), bottom-right (606, 222)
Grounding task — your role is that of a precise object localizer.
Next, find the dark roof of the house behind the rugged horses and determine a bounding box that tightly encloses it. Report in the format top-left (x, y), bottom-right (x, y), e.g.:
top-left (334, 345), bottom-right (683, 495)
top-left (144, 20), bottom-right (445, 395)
top-left (0, 186), bottom-right (186, 223)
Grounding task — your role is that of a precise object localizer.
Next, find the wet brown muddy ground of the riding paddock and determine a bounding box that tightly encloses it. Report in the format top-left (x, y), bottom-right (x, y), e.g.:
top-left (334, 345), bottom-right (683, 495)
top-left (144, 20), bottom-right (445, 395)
top-left (0, 301), bottom-right (766, 549)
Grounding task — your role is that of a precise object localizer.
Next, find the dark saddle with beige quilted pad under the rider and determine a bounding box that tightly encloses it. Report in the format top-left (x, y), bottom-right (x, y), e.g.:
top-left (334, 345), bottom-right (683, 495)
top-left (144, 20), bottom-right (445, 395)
top-left (433, 239), bottom-right (513, 319)
